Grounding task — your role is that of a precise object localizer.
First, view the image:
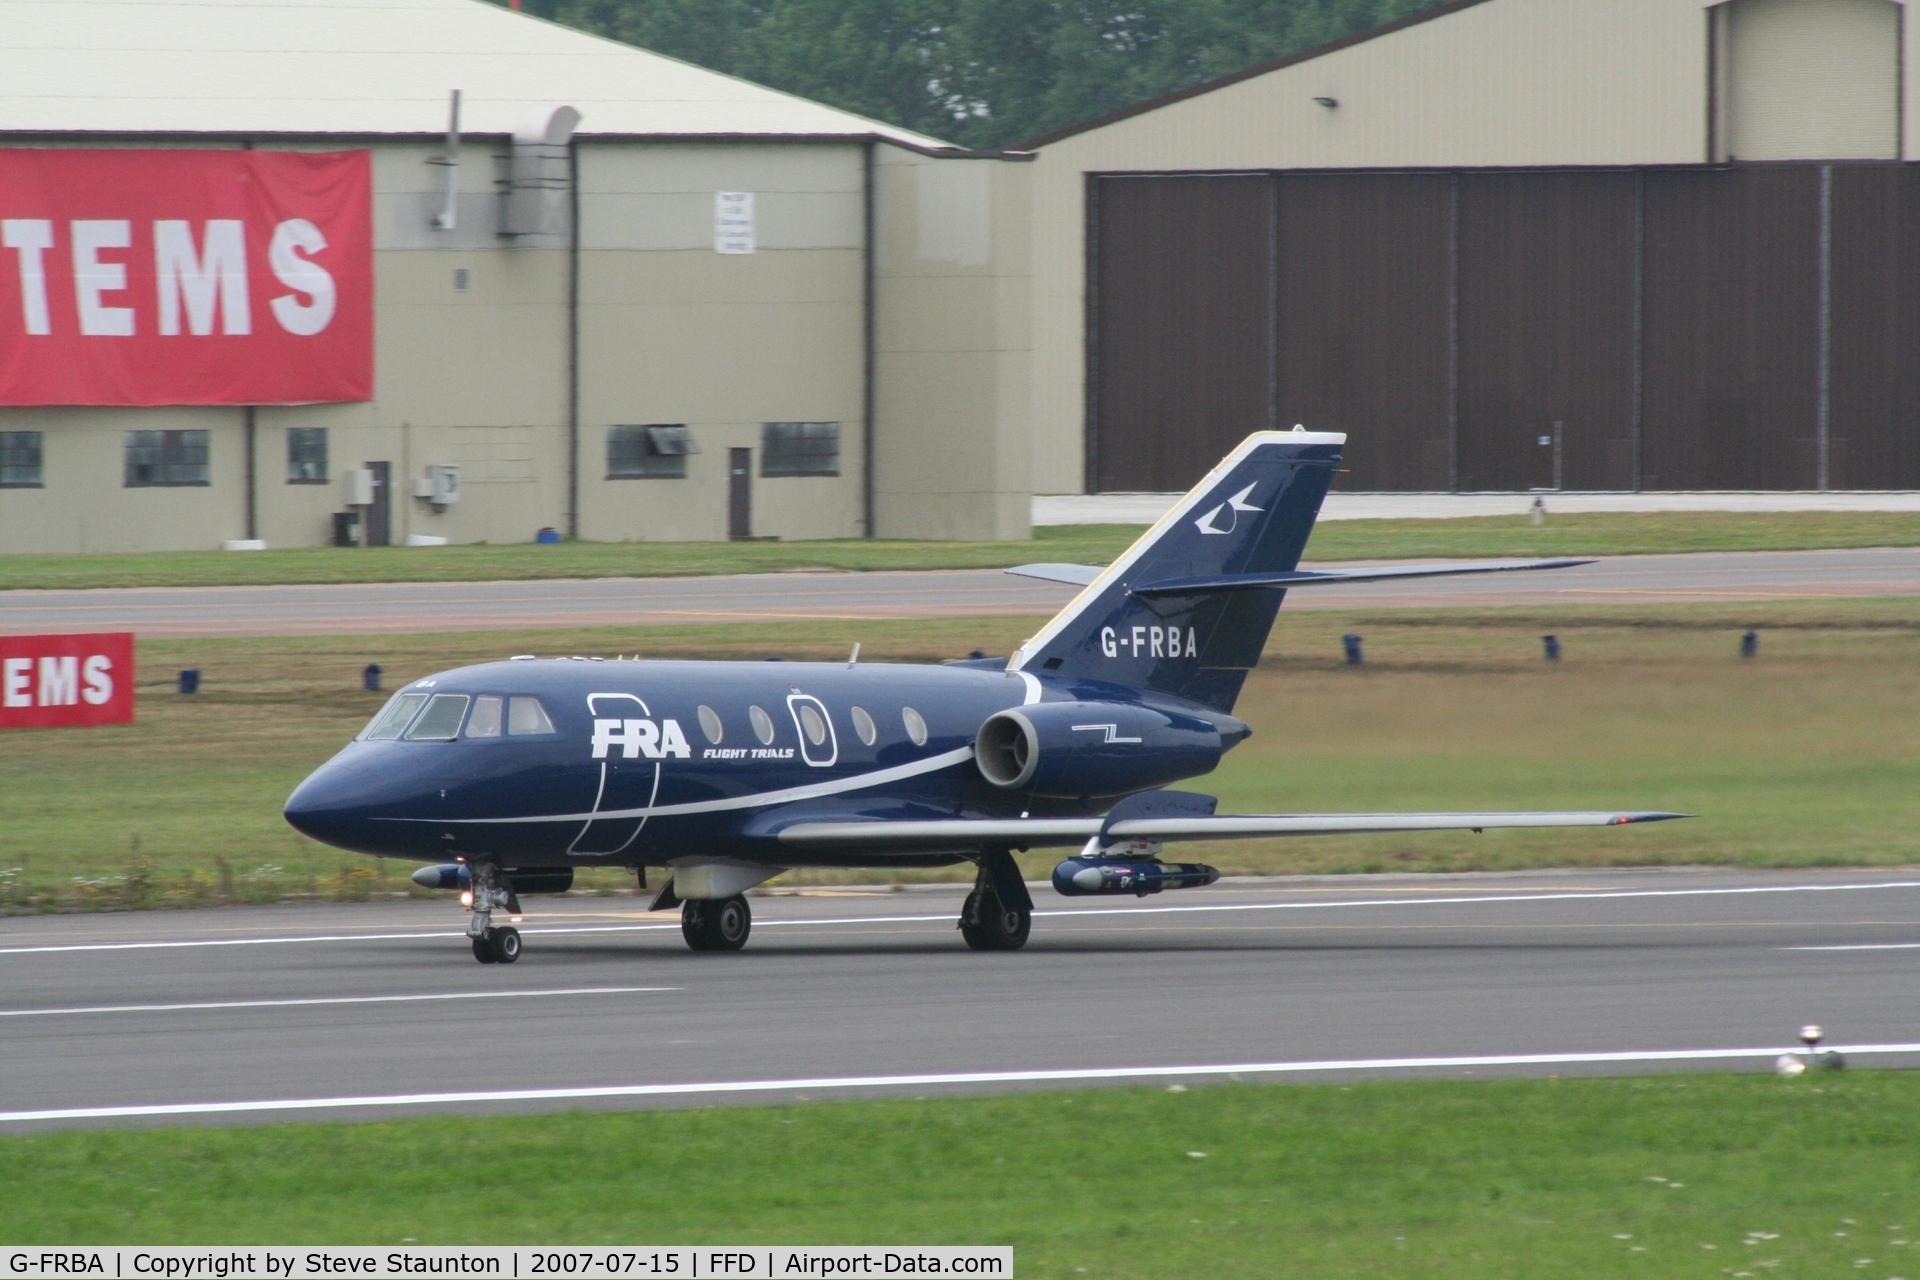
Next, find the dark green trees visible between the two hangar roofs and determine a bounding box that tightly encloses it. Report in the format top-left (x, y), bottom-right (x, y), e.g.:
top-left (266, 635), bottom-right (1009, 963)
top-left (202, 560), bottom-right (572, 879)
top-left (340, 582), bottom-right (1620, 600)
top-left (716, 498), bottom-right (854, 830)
top-left (495, 0), bottom-right (1440, 148)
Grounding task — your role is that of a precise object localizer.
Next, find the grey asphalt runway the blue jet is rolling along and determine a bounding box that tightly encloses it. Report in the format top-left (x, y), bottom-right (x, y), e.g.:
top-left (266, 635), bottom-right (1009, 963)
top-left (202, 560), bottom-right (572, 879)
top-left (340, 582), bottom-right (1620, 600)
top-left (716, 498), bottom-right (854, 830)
top-left (0, 869), bottom-right (1920, 1130)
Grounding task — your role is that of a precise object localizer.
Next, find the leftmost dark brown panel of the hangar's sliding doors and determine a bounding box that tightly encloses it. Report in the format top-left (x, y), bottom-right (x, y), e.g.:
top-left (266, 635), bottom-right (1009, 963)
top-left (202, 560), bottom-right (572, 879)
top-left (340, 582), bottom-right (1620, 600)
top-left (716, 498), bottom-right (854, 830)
top-left (1087, 175), bottom-right (1273, 493)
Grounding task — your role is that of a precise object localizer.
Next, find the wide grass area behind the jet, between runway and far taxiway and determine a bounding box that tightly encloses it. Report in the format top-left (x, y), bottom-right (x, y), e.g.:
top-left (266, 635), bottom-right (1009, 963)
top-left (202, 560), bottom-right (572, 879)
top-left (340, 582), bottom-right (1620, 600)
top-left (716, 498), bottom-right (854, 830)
top-left (0, 601), bottom-right (1920, 910)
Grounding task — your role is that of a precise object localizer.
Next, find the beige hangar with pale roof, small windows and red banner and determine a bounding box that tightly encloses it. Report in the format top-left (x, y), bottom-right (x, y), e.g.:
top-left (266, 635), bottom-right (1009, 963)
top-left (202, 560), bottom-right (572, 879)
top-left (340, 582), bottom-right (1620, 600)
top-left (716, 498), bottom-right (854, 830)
top-left (0, 0), bottom-right (1031, 551)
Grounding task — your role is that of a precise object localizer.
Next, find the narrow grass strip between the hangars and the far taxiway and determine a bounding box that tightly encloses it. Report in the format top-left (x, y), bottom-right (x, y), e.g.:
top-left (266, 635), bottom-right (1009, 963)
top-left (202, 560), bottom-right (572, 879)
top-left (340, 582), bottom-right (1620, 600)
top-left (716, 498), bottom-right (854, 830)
top-left (0, 510), bottom-right (1920, 591)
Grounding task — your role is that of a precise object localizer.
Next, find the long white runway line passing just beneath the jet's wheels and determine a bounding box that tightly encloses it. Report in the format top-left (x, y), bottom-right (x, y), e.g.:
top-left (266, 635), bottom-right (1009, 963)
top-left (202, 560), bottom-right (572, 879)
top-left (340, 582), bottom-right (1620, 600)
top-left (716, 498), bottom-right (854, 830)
top-left (0, 881), bottom-right (1920, 956)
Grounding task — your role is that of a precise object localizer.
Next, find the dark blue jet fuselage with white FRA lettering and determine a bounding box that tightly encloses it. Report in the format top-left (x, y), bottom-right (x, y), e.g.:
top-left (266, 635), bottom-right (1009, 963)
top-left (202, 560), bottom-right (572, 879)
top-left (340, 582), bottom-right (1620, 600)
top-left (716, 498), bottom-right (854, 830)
top-left (286, 658), bottom-right (1246, 867)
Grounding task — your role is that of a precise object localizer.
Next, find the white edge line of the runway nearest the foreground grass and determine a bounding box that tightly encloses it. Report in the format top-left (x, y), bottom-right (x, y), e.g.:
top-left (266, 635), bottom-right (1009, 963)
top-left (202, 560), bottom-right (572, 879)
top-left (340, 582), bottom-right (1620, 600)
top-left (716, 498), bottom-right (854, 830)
top-left (11, 1044), bottom-right (1920, 1125)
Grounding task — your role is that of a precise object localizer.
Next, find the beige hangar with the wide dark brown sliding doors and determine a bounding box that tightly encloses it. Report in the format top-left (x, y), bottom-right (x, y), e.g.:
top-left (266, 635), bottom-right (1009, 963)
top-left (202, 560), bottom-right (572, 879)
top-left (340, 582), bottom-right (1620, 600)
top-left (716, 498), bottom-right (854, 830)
top-left (1029, 0), bottom-right (1920, 493)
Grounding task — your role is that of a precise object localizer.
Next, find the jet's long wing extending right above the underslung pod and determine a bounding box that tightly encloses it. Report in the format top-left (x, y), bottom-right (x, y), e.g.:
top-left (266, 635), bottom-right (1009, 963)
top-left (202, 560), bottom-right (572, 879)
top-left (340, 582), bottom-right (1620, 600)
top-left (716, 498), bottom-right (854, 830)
top-left (778, 810), bottom-right (1686, 850)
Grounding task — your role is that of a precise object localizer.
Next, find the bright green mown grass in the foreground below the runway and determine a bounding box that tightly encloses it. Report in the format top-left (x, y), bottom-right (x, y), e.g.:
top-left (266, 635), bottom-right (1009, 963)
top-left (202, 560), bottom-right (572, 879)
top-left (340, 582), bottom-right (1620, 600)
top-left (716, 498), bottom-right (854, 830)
top-left (0, 1073), bottom-right (1920, 1280)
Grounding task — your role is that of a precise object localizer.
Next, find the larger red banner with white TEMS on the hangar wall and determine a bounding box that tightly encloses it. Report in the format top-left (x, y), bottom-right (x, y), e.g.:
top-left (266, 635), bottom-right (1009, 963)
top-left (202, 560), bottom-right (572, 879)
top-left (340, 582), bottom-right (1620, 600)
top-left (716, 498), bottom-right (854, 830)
top-left (0, 148), bottom-right (372, 405)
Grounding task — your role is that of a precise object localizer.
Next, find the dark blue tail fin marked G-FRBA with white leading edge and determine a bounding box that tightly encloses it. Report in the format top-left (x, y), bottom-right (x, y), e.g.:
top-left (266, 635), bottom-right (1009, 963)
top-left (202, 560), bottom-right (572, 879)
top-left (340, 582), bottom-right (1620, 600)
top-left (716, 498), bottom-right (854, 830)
top-left (1008, 432), bottom-right (1346, 712)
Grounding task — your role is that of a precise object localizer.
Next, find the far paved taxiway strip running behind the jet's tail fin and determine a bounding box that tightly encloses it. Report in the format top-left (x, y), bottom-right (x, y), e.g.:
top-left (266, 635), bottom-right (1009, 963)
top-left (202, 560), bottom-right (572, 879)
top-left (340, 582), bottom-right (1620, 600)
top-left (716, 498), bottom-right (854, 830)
top-left (0, 547), bottom-right (1920, 637)
